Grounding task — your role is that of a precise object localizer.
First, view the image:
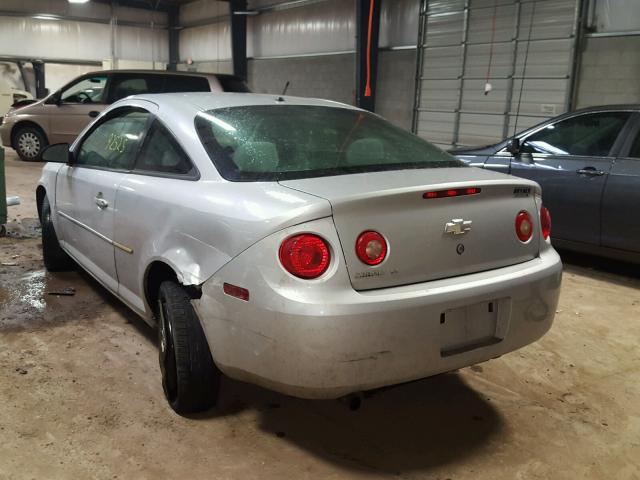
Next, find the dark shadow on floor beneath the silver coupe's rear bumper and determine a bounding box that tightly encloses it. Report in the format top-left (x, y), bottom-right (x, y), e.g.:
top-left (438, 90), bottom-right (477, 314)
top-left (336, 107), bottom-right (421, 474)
top-left (210, 373), bottom-right (504, 475)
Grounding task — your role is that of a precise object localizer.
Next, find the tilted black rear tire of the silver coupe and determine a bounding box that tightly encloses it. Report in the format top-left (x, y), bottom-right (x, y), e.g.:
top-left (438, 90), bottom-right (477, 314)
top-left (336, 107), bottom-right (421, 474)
top-left (158, 281), bottom-right (222, 414)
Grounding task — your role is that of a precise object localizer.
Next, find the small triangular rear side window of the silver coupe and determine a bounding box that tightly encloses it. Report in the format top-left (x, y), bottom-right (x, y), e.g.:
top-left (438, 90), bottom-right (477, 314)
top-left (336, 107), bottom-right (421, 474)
top-left (135, 121), bottom-right (195, 176)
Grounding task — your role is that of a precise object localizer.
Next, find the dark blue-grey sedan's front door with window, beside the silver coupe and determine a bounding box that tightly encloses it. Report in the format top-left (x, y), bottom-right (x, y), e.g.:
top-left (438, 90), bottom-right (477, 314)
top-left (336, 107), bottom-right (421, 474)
top-left (510, 111), bottom-right (631, 245)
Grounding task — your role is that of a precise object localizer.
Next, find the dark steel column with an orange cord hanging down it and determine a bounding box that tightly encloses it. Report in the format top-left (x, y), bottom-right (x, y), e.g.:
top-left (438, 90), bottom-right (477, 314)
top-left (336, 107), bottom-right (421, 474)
top-left (356, 0), bottom-right (382, 112)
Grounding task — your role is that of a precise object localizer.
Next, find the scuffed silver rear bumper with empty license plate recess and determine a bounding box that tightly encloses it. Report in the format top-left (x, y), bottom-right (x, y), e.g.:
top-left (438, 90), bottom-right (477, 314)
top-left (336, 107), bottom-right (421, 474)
top-left (194, 247), bottom-right (562, 398)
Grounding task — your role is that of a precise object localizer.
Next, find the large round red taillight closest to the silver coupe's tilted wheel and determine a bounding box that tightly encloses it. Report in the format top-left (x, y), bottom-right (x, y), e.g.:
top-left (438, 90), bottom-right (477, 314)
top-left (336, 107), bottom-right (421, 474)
top-left (278, 233), bottom-right (331, 279)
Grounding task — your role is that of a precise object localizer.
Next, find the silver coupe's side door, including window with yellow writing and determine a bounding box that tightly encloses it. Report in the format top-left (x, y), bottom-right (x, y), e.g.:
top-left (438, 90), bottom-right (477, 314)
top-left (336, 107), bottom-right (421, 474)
top-left (56, 108), bottom-right (150, 292)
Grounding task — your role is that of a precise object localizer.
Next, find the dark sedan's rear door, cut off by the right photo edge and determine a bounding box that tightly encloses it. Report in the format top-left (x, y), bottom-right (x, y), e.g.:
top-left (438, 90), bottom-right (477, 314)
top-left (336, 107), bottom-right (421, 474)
top-left (602, 113), bottom-right (640, 252)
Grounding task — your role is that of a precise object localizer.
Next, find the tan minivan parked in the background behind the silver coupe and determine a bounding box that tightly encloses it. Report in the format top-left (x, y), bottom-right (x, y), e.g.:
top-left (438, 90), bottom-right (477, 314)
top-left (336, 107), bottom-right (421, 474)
top-left (0, 70), bottom-right (249, 160)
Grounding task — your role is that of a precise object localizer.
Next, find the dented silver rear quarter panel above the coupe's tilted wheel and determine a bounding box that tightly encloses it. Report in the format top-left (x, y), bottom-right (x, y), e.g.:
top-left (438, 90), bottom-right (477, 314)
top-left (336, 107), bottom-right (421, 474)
top-left (114, 178), bottom-right (331, 313)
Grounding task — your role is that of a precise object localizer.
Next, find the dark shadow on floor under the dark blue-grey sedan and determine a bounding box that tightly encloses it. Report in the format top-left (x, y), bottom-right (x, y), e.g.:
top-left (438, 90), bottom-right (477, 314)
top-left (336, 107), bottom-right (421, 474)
top-left (558, 249), bottom-right (640, 288)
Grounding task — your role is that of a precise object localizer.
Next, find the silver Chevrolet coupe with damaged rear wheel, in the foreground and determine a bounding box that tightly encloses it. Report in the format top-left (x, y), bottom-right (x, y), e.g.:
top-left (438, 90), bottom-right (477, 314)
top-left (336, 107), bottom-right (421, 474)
top-left (36, 93), bottom-right (561, 413)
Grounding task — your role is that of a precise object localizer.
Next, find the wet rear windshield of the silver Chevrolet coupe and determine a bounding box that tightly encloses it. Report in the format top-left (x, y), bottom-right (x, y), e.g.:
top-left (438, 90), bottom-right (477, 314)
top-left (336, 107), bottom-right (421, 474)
top-left (195, 105), bottom-right (465, 181)
